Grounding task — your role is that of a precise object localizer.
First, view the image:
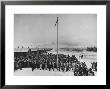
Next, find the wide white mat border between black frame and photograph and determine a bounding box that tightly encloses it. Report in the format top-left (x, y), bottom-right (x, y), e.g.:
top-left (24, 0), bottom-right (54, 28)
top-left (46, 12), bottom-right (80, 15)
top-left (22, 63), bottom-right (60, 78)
top-left (5, 5), bottom-right (106, 85)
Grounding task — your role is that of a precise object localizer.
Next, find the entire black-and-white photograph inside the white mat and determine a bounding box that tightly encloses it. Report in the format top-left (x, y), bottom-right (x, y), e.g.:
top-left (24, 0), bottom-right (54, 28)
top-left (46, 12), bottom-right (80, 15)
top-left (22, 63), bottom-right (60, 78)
top-left (13, 14), bottom-right (98, 76)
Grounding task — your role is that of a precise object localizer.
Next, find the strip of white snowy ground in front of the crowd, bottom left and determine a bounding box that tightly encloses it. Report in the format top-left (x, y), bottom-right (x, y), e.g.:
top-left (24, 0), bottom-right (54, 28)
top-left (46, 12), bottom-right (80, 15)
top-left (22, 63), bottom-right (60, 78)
top-left (14, 68), bottom-right (74, 76)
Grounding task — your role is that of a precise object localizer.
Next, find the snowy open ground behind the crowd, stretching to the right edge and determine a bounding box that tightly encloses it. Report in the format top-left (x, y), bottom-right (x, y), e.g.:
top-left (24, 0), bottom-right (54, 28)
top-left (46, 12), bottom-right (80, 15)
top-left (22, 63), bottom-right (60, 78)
top-left (49, 51), bottom-right (97, 68)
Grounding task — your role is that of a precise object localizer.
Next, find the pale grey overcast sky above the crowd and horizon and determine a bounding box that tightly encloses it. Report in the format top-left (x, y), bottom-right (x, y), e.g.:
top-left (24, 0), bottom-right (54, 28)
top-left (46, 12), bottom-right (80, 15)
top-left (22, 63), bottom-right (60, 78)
top-left (14, 14), bottom-right (97, 48)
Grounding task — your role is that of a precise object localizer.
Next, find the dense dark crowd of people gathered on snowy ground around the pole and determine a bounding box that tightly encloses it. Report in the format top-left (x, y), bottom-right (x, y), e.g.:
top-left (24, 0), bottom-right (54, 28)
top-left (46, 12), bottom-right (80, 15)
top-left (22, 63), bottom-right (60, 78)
top-left (14, 49), bottom-right (97, 76)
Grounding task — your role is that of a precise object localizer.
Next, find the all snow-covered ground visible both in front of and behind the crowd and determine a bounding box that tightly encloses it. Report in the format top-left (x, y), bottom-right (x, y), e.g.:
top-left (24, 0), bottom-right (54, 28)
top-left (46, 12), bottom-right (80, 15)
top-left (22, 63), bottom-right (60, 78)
top-left (14, 51), bottom-right (97, 76)
